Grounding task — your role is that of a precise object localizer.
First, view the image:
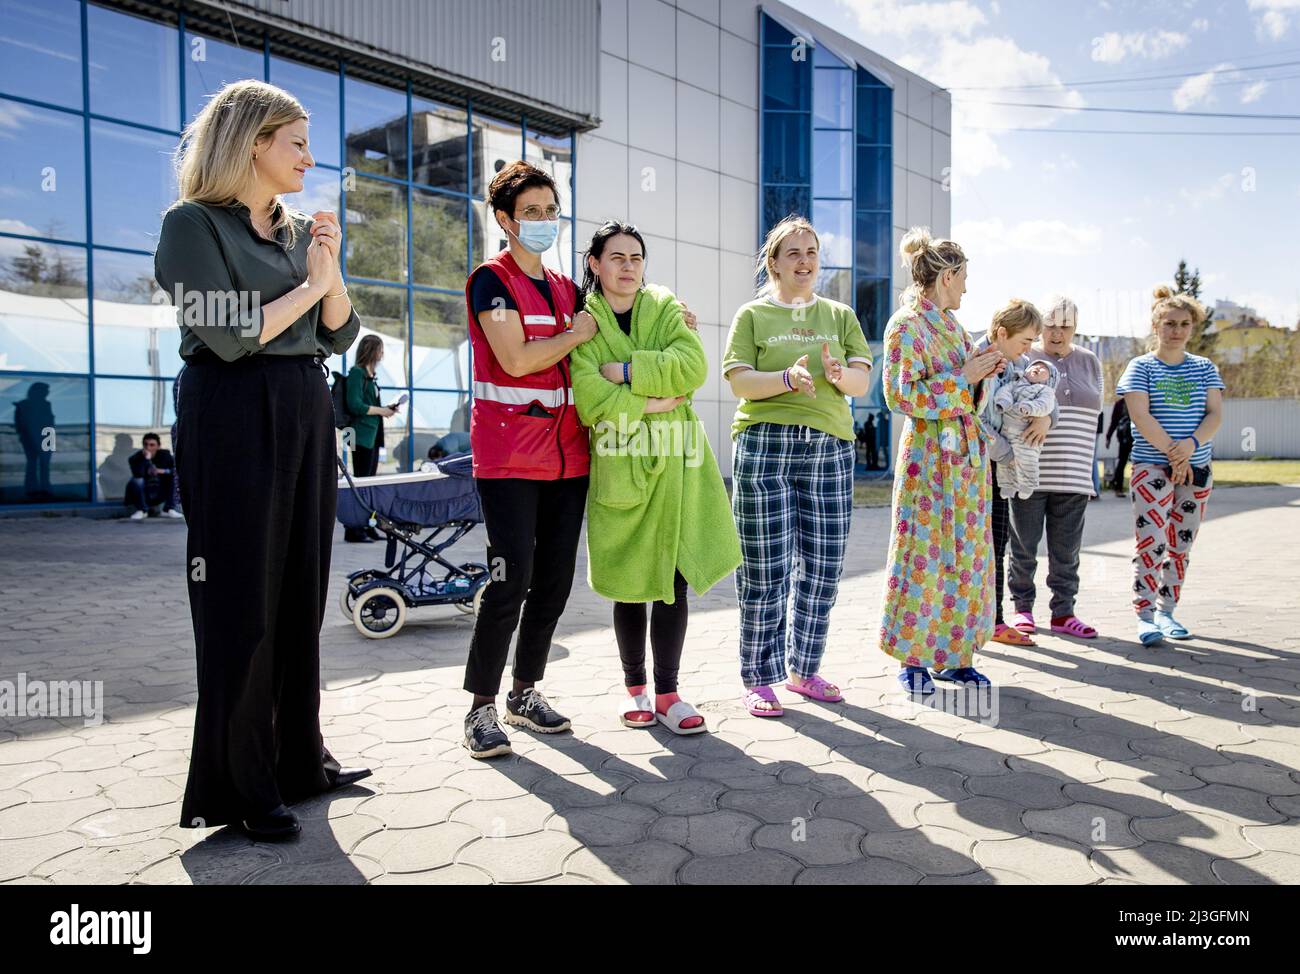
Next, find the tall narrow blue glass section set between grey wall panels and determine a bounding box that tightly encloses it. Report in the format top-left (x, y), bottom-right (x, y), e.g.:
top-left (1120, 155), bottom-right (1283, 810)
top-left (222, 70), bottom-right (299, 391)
top-left (759, 14), bottom-right (893, 472)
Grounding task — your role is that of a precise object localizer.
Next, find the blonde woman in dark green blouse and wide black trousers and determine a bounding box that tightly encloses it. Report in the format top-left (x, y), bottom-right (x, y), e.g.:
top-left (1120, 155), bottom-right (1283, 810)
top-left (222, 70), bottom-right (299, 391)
top-left (153, 81), bottom-right (371, 840)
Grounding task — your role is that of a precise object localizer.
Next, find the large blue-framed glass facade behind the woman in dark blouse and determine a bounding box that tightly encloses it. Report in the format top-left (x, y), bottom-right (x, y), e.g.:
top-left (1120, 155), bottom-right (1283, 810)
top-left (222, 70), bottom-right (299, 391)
top-left (0, 0), bottom-right (575, 506)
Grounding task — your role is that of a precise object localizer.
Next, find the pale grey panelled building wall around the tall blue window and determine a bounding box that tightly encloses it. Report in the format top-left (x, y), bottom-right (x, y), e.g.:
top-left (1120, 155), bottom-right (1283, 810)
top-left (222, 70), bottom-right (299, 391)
top-left (575, 0), bottom-right (952, 476)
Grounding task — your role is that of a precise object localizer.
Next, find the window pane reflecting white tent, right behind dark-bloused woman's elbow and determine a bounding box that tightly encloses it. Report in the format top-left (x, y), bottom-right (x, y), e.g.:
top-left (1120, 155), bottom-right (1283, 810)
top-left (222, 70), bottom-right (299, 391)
top-left (95, 250), bottom-right (181, 377)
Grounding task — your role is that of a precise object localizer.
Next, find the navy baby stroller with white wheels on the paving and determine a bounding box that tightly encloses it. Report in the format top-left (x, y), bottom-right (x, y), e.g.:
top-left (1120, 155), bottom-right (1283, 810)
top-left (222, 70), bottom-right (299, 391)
top-left (335, 454), bottom-right (489, 640)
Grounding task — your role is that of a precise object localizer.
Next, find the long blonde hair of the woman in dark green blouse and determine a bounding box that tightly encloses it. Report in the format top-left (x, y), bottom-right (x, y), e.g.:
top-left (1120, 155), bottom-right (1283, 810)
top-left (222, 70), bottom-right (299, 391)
top-left (174, 81), bottom-right (307, 242)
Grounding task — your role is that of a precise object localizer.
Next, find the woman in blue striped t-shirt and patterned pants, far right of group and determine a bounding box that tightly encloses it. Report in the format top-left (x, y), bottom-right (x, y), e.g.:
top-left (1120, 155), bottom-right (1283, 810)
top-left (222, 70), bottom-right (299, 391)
top-left (1117, 285), bottom-right (1223, 646)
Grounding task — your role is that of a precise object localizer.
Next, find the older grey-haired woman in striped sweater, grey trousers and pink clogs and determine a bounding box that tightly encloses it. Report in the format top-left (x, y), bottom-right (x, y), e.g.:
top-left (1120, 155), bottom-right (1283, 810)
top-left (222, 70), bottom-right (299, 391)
top-left (1008, 298), bottom-right (1102, 640)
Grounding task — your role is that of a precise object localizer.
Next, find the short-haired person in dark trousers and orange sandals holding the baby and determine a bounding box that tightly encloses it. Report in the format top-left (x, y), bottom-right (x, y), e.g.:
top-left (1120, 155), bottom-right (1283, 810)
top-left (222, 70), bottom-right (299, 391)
top-left (975, 298), bottom-right (1058, 646)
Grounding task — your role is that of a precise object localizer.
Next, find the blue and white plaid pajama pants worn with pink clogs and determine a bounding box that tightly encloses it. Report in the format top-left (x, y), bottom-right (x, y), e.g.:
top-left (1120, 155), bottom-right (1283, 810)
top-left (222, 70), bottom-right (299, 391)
top-left (732, 423), bottom-right (853, 687)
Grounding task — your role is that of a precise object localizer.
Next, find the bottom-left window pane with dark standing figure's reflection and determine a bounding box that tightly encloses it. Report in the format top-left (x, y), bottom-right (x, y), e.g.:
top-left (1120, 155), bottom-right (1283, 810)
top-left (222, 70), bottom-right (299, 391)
top-left (0, 373), bottom-right (91, 503)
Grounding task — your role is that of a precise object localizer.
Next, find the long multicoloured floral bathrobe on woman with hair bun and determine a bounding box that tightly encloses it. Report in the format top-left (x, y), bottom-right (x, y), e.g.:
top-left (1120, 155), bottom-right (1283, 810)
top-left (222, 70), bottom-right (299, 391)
top-left (880, 298), bottom-right (993, 668)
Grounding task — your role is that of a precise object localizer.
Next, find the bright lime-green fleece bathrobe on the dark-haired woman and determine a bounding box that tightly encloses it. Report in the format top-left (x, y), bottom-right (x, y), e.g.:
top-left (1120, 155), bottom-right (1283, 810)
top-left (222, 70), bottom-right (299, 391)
top-left (569, 285), bottom-right (740, 602)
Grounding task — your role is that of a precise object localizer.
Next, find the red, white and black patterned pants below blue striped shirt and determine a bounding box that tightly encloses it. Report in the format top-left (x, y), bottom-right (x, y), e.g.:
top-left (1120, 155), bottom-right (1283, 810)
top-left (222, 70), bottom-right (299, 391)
top-left (1128, 463), bottom-right (1214, 622)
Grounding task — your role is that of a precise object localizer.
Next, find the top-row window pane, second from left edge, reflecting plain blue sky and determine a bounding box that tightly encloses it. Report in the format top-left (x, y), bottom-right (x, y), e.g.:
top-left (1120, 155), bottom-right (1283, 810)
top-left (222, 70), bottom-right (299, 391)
top-left (88, 4), bottom-right (181, 129)
